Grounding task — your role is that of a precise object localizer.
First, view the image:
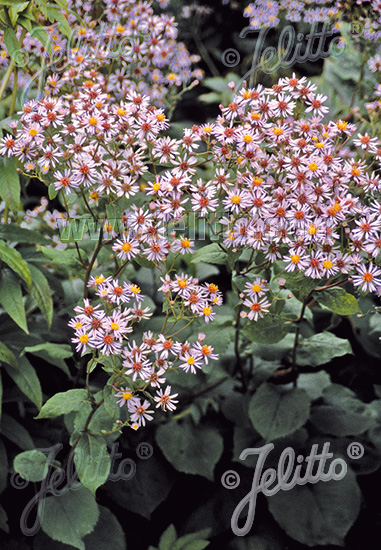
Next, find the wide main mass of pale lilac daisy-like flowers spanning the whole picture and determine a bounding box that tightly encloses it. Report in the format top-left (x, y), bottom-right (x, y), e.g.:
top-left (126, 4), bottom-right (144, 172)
top-left (0, 75), bottom-right (381, 302)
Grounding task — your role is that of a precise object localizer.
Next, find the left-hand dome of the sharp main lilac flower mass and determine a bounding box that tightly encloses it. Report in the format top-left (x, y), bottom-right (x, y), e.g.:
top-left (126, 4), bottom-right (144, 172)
top-left (0, 85), bottom-right (168, 189)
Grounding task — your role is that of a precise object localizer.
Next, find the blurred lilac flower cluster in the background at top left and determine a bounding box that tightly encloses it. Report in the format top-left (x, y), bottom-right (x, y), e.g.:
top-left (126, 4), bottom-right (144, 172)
top-left (0, 0), bottom-right (203, 106)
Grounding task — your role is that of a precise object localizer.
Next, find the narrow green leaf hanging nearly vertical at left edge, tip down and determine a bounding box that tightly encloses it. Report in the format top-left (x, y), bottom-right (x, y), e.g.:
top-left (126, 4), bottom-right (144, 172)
top-left (0, 270), bottom-right (29, 334)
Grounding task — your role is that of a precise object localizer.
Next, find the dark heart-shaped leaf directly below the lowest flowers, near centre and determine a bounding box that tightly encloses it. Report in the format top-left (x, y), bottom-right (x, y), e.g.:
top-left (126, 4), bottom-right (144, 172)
top-left (156, 420), bottom-right (223, 481)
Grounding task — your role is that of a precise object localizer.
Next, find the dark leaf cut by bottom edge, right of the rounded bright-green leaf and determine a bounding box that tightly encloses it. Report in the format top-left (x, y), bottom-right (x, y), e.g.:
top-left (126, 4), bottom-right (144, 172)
top-left (83, 506), bottom-right (126, 550)
